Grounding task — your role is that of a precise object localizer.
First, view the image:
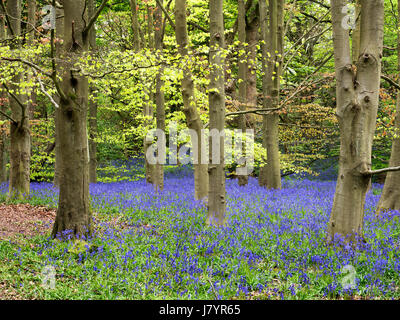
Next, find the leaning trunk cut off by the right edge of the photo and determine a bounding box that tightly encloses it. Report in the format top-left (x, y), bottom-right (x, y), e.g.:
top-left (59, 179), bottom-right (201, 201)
top-left (376, 1), bottom-right (400, 214)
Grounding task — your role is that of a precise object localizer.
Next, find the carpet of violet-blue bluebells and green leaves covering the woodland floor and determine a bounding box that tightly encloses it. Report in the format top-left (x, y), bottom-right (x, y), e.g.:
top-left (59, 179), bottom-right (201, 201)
top-left (0, 172), bottom-right (400, 299)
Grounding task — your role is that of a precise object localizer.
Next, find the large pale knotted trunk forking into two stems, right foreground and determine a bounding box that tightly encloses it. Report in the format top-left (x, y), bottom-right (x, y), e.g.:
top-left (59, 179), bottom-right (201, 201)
top-left (328, 0), bottom-right (383, 240)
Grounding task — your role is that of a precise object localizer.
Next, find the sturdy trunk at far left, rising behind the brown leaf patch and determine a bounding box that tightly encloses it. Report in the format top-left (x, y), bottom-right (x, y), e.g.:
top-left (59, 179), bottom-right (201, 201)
top-left (7, 0), bottom-right (31, 199)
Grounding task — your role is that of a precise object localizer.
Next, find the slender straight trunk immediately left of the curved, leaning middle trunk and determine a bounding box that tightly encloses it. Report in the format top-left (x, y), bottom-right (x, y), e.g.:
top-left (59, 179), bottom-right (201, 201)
top-left (154, 0), bottom-right (165, 191)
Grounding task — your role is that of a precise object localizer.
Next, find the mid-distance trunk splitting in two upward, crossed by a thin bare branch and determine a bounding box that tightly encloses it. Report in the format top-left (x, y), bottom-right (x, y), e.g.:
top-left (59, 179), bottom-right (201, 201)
top-left (259, 0), bottom-right (285, 189)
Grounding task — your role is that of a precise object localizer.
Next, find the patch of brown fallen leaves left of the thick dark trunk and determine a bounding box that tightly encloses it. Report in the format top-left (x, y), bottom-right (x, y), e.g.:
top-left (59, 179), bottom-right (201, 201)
top-left (0, 204), bottom-right (56, 240)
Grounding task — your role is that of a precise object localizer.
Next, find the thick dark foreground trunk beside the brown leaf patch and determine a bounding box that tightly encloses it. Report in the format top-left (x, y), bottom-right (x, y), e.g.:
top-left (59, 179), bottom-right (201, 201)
top-left (52, 0), bottom-right (92, 237)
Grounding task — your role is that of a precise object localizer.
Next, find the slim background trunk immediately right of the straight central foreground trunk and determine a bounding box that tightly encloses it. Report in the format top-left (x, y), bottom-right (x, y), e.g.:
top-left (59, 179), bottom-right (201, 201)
top-left (238, 0), bottom-right (248, 186)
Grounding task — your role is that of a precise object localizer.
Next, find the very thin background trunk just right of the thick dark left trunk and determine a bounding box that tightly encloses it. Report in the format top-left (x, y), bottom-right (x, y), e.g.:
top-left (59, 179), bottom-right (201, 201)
top-left (88, 0), bottom-right (97, 183)
